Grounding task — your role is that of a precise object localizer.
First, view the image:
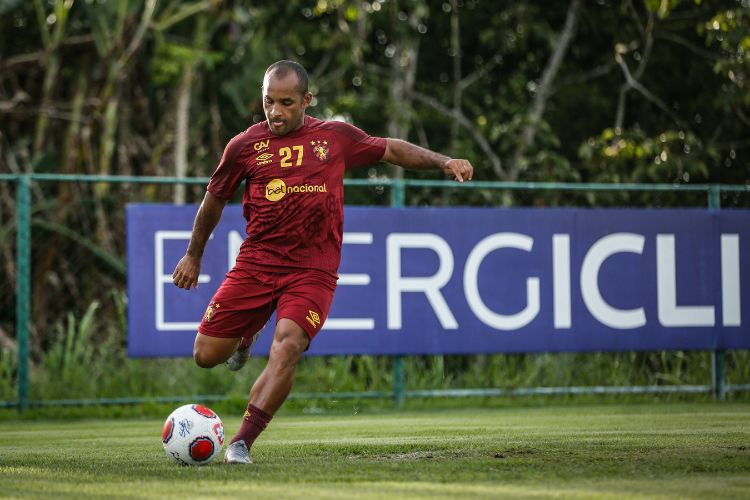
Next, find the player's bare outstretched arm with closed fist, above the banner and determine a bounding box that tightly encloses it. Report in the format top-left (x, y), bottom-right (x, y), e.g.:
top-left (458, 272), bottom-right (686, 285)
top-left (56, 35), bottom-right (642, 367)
top-left (383, 137), bottom-right (474, 182)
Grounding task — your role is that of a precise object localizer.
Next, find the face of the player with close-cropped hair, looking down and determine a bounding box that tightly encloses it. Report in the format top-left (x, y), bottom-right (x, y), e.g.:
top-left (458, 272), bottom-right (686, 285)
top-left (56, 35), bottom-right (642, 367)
top-left (263, 71), bottom-right (312, 136)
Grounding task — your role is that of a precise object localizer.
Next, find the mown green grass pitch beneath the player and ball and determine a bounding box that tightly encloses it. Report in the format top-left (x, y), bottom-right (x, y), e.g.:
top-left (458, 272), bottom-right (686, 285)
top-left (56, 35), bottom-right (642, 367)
top-left (0, 403), bottom-right (750, 500)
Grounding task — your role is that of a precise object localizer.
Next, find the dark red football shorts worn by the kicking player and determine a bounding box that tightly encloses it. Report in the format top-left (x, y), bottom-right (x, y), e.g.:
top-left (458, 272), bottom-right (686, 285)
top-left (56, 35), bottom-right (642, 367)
top-left (198, 267), bottom-right (336, 340)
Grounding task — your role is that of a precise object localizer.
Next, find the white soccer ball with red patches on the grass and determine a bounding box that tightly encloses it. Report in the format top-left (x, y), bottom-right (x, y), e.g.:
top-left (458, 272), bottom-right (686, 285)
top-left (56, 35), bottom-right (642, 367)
top-left (161, 404), bottom-right (224, 465)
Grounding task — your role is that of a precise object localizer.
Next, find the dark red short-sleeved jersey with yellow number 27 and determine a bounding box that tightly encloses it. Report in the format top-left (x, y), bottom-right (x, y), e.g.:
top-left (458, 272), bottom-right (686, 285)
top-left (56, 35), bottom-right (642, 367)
top-left (208, 116), bottom-right (386, 275)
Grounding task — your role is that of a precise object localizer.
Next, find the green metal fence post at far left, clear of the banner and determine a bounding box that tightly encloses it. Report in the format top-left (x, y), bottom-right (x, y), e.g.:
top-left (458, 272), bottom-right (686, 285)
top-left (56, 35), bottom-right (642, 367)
top-left (16, 175), bottom-right (31, 411)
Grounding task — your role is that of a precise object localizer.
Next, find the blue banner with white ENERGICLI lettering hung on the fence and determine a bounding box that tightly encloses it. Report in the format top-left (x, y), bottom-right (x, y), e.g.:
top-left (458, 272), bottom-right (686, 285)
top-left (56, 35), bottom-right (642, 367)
top-left (127, 205), bottom-right (750, 356)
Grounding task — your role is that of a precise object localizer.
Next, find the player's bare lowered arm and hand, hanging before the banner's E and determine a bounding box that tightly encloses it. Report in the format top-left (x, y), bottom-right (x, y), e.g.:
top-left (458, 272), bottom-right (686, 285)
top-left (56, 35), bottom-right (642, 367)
top-left (172, 191), bottom-right (227, 290)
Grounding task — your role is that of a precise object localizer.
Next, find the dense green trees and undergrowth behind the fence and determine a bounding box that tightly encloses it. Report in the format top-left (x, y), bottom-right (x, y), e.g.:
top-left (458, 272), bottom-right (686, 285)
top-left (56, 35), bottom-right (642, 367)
top-left (0, 0), bottom-right (750, 410)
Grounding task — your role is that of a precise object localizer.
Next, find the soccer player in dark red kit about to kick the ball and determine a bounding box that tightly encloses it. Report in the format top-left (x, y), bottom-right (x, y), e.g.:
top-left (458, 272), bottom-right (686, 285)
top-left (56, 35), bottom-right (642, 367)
top-left (172, 61), bottom-right (473, 464)
